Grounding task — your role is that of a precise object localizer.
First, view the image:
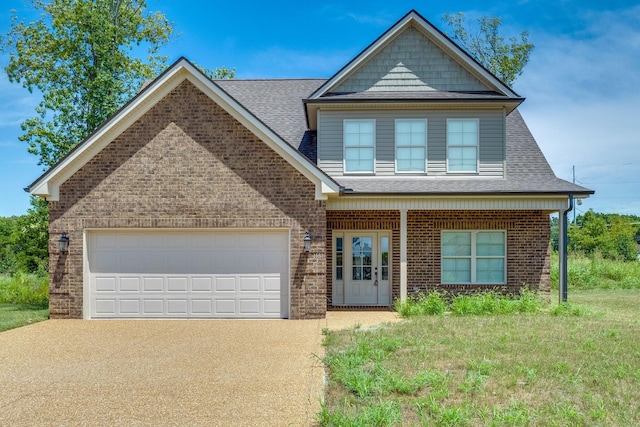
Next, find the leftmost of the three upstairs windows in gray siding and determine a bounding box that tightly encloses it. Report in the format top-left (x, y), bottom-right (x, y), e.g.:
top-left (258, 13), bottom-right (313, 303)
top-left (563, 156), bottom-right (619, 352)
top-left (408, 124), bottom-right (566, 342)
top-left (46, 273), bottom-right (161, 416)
top-left (344, 120), bottom-right (376, 173)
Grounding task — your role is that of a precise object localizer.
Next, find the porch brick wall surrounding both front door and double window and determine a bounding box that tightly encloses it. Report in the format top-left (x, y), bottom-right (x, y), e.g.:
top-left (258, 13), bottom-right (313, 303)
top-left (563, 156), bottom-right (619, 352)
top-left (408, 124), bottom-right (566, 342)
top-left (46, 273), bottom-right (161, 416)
top-left (327, 211), bottom-right (550, 305)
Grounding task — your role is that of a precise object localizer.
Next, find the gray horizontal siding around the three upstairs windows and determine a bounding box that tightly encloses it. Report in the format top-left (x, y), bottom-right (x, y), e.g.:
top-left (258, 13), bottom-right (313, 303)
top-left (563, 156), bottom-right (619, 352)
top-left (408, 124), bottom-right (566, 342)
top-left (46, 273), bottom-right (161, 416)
top-left (318, 110), bottom-right (506, 176)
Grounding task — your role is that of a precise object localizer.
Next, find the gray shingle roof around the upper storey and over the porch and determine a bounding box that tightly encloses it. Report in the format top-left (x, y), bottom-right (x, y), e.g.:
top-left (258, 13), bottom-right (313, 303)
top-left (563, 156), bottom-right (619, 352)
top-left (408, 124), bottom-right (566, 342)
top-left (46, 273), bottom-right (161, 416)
top-left (216, 79), bottom-right (593, 195)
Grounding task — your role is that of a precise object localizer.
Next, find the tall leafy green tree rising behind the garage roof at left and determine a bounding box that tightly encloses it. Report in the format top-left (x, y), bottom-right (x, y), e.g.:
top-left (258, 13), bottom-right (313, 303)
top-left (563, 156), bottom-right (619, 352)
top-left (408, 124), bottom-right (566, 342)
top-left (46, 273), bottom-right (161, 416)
top-left (0, 0), bottom-right (172, 166)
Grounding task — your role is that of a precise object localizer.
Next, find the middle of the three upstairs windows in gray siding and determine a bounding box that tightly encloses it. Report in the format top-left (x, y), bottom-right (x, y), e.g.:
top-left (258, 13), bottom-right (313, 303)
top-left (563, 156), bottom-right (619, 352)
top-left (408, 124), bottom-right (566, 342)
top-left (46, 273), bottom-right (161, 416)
top-left (396, 120), bottom-right (427, 172)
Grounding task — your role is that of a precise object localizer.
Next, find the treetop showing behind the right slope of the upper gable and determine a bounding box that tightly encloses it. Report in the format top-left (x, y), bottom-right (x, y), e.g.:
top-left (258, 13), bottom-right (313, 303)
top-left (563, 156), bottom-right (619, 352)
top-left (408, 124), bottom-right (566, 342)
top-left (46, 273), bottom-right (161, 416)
top-left (442, 12), bottom-right (533, 86)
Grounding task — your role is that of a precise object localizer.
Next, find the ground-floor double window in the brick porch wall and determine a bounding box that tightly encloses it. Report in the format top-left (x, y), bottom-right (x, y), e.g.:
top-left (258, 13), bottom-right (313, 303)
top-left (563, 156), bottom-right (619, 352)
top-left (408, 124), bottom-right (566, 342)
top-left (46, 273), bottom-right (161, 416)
top-left (441, 231), bottom-right (506, 284)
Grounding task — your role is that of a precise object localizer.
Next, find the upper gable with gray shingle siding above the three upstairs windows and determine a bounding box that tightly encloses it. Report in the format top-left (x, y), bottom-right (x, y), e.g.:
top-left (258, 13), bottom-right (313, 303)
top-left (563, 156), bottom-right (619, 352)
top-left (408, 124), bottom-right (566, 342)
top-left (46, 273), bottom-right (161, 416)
top-left (304, 10), bottom-right (524, 129)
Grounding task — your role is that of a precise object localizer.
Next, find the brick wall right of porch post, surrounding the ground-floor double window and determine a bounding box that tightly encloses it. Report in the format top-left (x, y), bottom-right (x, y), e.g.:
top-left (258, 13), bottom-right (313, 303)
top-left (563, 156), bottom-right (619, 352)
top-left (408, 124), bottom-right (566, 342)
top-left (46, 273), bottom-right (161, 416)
top-left (407, 211), bottom-right (550, 294)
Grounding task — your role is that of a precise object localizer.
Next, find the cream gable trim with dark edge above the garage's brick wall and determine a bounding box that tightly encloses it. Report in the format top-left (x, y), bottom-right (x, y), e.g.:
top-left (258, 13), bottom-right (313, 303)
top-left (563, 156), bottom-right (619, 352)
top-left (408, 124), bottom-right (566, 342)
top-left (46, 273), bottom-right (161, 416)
top-left (28, 58), bottom-right (340, 201)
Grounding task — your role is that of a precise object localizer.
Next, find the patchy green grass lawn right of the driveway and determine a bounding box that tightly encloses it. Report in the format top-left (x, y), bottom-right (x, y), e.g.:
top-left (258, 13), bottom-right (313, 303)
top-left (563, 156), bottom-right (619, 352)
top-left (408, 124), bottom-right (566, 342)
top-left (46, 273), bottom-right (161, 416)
top-left (319, 289), bottom-right (640, 426)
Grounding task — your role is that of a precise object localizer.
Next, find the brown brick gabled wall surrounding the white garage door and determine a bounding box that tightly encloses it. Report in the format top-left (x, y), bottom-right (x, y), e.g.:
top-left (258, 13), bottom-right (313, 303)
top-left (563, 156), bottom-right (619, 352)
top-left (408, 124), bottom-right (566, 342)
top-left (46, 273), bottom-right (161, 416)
top-left (49, 82), bottom-right (326, 319)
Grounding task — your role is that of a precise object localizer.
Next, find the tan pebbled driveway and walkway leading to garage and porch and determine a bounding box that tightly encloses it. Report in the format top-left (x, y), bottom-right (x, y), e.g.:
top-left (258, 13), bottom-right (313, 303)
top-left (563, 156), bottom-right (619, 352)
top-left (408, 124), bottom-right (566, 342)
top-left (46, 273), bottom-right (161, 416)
top-left (0, 312), bottom-right (397, 426)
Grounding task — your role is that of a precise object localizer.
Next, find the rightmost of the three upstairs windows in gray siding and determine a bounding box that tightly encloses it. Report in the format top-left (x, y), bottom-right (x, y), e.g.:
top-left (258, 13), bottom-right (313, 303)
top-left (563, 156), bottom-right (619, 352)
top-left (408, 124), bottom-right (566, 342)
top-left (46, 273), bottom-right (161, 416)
top-left (447, 119), bottom-right (478, 172)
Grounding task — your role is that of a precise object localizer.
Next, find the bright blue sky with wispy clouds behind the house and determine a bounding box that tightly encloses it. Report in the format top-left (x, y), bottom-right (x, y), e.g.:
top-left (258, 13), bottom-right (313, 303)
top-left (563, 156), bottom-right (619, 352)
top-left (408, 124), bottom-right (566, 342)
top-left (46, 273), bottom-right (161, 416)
top-left (0, 0), bottom-right (640, 216)
